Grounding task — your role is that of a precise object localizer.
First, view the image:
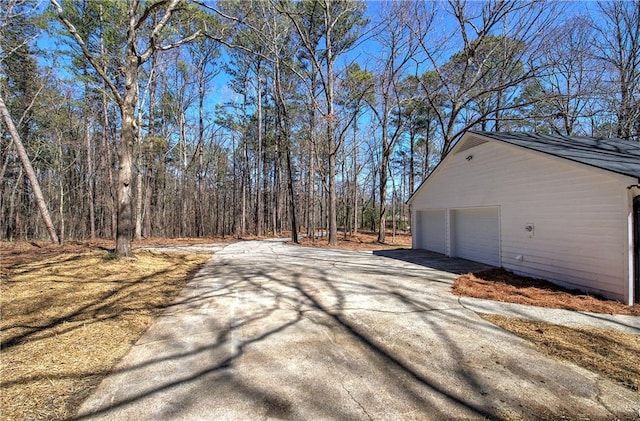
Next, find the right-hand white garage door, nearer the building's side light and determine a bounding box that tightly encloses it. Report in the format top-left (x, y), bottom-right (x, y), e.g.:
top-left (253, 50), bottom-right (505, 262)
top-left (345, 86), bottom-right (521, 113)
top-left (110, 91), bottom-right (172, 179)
top-left (451, 207), bottom-right (500, 266)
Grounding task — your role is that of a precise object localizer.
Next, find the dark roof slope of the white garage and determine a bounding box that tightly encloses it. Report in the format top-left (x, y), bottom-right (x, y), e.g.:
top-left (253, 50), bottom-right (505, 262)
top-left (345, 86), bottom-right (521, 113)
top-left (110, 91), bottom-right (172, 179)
top-left (471, 131), bottom-right (640, 179)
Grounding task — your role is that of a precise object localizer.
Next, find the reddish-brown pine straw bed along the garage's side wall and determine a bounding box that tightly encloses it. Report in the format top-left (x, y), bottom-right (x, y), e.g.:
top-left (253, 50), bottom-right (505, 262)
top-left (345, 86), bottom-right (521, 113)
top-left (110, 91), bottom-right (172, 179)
top-left (453, 269), bottom-right (640, 316)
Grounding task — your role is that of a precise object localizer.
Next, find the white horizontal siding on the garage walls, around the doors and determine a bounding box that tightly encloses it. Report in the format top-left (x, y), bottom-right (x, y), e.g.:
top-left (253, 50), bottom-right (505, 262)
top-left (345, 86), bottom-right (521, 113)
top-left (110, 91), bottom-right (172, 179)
top-left (411, 141), bottom-right (637, 300)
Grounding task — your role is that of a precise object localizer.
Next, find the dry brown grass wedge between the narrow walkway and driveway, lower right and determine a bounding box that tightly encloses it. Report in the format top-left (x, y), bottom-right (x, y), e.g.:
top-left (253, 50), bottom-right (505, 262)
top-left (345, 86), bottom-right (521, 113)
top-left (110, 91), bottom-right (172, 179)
top-left (481, 314), bottom-right (640, 391)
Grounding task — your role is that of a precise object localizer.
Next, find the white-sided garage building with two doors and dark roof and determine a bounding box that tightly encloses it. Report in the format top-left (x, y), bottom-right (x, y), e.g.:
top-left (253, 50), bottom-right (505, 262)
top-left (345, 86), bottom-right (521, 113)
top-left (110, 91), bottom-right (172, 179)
top-left (409, 132), bottom-right (640, 304)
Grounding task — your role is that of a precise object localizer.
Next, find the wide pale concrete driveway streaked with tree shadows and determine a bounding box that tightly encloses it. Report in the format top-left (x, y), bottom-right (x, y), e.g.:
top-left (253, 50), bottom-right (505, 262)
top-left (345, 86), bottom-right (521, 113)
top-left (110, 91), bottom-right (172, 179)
top-left (79, 240), bottom-right (640, 420)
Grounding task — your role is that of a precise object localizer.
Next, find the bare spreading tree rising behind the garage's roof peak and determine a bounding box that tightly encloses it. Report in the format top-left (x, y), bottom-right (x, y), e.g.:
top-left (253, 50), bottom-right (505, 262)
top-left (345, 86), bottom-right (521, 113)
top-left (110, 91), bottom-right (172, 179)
top-left (410, 0), bottom-right (558, 154)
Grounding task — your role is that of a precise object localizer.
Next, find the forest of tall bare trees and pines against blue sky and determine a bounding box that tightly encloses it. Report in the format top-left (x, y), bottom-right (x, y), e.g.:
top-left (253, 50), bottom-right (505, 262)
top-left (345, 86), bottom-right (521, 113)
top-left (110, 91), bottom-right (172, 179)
top-left (0, 0), bottom-right (640, 256)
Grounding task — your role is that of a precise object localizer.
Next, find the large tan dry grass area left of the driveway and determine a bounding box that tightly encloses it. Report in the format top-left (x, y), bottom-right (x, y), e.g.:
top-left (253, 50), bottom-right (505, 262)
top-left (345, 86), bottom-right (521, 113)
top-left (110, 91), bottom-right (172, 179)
top-left (0, 241), bottom-right (209, 420)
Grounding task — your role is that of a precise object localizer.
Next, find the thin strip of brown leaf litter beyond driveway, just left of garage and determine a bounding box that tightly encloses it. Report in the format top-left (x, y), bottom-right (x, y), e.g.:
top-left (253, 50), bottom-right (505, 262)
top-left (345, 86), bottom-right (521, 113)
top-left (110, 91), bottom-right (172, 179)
top-left (289, 232), bottom-right (411, 251)
